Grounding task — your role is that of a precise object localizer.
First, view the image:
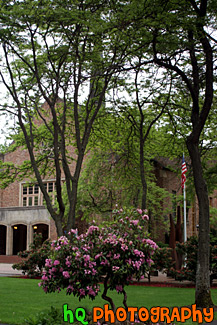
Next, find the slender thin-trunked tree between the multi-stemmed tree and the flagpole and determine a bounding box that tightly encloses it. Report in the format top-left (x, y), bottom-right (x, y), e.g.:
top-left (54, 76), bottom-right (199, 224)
top-left (110, 55), bottom-right (172, 210)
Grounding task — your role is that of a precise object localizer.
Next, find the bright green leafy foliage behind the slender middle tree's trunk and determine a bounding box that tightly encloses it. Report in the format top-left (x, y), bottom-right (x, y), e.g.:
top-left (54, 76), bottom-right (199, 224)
top-left (77, 109), bottom-right (170, 223)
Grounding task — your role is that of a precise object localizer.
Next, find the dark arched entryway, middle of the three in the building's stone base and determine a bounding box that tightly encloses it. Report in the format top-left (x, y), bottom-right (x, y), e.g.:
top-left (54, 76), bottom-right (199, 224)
top-left (12, 224), bottom-right (27, 255)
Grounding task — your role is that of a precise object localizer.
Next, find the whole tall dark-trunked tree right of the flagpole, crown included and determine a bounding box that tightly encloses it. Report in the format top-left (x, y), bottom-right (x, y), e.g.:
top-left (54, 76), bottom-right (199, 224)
top-left (147, 0), bottom-right (216, 307)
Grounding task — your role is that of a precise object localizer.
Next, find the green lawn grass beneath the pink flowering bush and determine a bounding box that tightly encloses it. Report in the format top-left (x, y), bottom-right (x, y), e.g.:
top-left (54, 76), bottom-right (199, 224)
top-left (0, 277), bottom-right (217, 324)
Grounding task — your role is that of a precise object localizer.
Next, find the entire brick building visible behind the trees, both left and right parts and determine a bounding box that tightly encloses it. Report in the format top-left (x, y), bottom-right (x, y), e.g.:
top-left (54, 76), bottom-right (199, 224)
top-left (0, 140), bottom-right (214, 256)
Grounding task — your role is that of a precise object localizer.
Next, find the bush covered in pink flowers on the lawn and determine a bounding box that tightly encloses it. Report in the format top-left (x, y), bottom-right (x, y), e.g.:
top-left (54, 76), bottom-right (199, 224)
top-left (39, 209), bottom-right (157, 310)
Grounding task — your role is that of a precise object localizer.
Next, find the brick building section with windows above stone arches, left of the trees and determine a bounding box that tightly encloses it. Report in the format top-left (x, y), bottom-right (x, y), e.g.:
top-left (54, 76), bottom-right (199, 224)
top-left (0, 149), bottom-right (56, 255)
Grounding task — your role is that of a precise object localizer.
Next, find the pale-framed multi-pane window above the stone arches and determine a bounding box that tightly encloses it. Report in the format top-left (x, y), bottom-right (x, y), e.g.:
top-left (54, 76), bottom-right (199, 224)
top-left (21, 181), bottom-right (56, 207)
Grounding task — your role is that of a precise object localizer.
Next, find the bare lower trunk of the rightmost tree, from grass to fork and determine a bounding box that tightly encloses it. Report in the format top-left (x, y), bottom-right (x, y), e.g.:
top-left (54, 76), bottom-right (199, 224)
top-left (187, 136), bottom-right (213, 307)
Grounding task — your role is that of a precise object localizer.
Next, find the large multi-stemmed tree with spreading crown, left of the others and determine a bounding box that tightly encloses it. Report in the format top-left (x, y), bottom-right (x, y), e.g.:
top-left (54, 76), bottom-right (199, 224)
top-left (0, 0), bottom-right (133, 235)
